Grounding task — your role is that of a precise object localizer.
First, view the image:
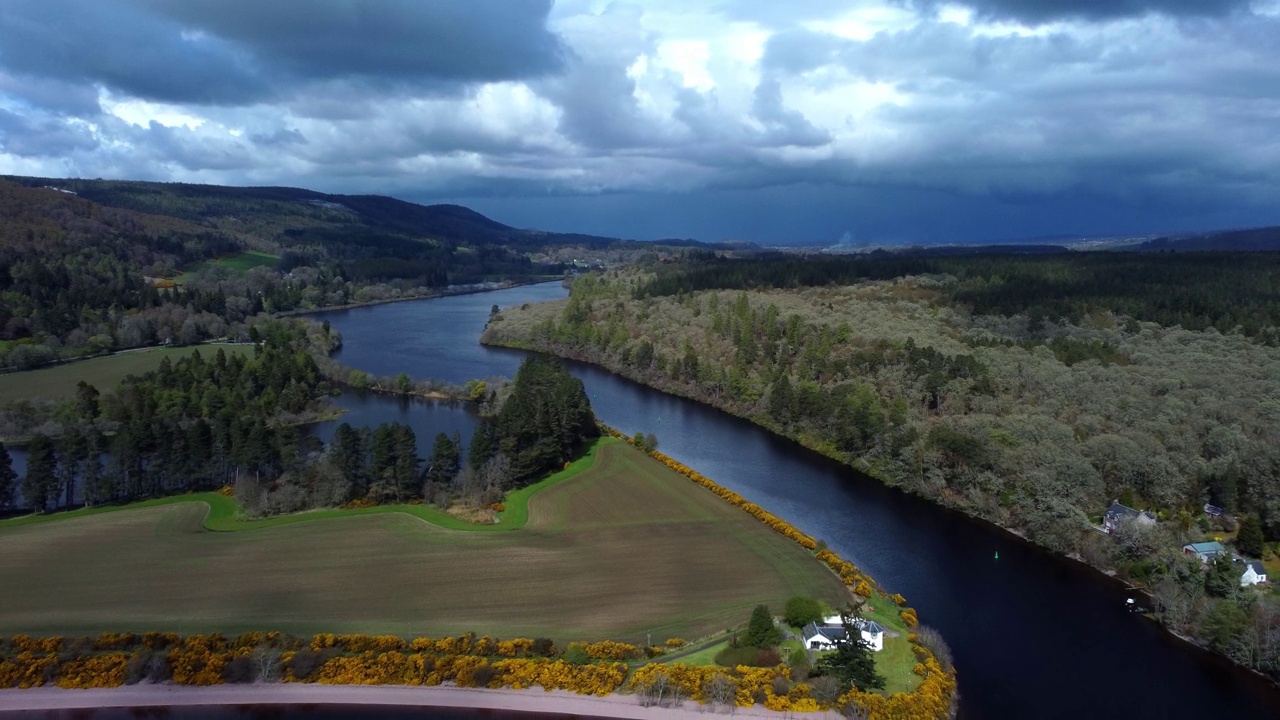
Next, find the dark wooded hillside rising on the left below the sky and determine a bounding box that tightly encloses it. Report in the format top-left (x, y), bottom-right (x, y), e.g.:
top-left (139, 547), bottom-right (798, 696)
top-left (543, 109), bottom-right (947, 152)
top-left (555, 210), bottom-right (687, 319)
top-left (0, 177), bottom-right (691, 369)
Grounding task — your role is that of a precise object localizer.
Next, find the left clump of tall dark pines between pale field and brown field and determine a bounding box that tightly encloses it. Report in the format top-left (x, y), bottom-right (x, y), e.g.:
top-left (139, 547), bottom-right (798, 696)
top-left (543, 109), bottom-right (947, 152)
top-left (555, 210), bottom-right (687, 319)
top-left (0, 322), bottom-right (329, 511)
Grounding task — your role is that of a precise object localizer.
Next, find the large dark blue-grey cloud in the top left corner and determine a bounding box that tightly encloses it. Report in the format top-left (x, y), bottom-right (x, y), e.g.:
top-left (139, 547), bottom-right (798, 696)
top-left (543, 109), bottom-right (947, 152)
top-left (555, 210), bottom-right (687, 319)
top-left (0, 0), bottom-right (563, 105)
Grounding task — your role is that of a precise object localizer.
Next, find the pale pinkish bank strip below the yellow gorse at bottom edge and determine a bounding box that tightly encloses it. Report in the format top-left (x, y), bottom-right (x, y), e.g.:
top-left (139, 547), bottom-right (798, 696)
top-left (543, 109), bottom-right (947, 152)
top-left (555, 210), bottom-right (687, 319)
top-left (0, 683), bottom-right (840, 720)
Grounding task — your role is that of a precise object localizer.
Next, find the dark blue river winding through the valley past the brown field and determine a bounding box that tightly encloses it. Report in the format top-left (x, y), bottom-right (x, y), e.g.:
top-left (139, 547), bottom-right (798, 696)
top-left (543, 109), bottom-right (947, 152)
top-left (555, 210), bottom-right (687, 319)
top-left (307, 283), bottom-right (1280, 720)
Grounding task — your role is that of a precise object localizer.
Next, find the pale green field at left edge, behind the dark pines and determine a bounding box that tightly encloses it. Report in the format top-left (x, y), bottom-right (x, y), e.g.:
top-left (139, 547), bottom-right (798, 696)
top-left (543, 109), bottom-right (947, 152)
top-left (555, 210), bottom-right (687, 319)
top-left (0, 345), bottom-right (253, 406)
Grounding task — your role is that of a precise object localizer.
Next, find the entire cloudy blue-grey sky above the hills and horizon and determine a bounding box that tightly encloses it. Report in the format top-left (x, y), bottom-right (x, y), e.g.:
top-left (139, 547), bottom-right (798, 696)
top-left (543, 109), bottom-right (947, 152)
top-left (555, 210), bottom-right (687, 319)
top-left (0, 0), bottom-right (1280, 243)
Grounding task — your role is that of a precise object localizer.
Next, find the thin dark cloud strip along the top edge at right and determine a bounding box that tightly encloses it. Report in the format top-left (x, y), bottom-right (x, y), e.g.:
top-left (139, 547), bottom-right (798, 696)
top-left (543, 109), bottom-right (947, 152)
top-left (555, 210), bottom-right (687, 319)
top-left (899, 0), bottom-right (1249, 24)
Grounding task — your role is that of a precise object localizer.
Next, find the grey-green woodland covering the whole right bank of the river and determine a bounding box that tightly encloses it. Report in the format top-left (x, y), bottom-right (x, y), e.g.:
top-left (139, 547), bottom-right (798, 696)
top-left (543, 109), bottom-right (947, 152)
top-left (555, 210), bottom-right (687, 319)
top-left (485, 254), bottom-right (1280, 673)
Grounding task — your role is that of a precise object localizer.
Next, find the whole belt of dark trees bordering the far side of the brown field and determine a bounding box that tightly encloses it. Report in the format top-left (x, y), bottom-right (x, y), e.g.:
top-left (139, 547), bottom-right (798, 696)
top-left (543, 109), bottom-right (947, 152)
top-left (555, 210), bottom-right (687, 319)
top-left (0, 335), bottom-right (599, 515)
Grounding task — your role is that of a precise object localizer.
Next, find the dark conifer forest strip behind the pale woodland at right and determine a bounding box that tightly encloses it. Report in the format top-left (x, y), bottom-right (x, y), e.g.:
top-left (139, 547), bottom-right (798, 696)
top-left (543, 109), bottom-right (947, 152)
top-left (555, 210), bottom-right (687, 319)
top-left (635, 252), bottom-right (1280, 346)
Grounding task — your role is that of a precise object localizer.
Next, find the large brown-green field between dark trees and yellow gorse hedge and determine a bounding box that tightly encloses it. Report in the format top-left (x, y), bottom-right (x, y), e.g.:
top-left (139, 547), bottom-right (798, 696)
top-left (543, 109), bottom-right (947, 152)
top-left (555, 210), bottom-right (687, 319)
top-left (0, 442), bottom-right (847, 642)
